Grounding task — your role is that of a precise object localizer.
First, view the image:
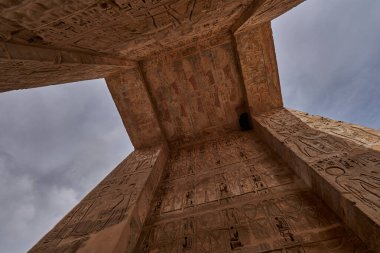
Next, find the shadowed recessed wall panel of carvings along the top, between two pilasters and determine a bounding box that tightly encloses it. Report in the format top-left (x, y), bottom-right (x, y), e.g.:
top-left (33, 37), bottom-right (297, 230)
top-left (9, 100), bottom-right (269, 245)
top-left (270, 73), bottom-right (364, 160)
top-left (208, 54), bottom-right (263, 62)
top-left (0, 0), bottom-right (253, 58)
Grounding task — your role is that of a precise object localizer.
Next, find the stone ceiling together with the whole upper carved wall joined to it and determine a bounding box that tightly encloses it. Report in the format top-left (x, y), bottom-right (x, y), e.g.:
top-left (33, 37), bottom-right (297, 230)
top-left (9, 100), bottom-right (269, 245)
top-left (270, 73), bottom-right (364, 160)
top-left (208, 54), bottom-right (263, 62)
top-left (0, 0), bottom-right (303, 148)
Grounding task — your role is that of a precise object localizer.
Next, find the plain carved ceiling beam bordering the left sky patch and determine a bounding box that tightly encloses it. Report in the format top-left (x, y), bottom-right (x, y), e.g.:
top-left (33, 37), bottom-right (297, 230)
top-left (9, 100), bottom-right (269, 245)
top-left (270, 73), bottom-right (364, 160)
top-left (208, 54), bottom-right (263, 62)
top-left (106, 68), bottom-right (166, 148)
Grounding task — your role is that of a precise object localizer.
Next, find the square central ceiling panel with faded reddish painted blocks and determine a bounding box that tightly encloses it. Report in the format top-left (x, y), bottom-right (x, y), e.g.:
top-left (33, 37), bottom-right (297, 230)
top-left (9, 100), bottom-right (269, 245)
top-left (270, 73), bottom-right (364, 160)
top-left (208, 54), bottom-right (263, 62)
top-left (143, 37), bottom-right (243, 142)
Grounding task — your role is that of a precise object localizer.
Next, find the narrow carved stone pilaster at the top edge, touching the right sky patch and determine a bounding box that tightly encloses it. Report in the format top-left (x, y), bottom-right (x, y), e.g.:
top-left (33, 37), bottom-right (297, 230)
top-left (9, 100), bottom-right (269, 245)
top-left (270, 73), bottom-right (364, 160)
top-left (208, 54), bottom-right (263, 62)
top-left (231, 0), bottom-right (304, 33)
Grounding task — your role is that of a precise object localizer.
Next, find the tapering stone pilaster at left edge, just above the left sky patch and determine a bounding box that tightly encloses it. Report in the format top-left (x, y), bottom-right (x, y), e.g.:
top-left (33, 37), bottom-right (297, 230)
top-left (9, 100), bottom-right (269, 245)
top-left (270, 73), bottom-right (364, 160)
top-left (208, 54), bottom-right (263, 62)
top-left (0, 42), bottom-right (137, 92)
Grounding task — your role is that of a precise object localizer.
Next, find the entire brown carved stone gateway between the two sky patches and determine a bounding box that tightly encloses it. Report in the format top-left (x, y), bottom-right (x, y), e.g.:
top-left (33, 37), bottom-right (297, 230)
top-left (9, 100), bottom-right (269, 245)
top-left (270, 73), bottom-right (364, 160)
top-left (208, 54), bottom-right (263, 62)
top-left (5, 0), bottom-right (380, 253)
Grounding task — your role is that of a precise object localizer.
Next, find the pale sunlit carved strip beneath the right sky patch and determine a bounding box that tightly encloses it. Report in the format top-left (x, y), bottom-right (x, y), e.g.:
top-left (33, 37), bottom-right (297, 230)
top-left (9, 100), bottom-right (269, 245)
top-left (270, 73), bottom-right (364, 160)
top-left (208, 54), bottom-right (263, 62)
top-left (290, 110), bottom-right (380, 151)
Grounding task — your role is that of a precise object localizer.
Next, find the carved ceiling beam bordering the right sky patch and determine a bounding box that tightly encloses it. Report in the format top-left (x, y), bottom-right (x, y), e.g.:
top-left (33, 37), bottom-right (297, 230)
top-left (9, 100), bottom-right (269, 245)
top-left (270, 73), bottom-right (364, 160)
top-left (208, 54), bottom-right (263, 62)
top-left (235, 23), bottom-right (282, 115)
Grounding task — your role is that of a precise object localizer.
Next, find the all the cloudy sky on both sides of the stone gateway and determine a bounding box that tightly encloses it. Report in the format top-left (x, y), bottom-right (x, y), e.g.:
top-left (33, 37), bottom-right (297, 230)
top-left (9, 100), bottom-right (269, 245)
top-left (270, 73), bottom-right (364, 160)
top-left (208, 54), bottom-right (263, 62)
top-left (0, 0), bottom-right (380, 253)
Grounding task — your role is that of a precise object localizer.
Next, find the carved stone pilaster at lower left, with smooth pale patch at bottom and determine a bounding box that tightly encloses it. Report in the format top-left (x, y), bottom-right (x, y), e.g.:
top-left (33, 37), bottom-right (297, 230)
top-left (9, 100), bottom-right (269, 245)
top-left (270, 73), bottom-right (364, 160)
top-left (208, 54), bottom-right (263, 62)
top-left (29, 146), bottom-right (168, 253)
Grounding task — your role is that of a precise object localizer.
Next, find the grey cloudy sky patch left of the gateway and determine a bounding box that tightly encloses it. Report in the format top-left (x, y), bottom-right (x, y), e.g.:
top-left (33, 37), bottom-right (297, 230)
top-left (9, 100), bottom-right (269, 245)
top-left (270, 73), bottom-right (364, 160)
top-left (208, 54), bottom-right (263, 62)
top-left (0, 80), bottom-right (133, 253)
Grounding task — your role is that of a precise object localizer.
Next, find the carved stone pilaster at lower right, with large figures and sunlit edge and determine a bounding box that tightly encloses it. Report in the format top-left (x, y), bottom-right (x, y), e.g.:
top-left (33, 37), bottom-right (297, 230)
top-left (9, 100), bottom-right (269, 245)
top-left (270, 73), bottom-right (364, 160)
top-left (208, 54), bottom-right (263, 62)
top-left (254, 109), bottom-right (380, 252)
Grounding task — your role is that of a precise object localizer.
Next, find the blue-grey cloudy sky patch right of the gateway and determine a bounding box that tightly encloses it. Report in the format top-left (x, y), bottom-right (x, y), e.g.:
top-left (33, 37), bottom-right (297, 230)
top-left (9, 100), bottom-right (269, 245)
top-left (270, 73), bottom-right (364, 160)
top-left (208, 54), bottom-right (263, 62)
top-left (273, 0), bottom-right (380, 128)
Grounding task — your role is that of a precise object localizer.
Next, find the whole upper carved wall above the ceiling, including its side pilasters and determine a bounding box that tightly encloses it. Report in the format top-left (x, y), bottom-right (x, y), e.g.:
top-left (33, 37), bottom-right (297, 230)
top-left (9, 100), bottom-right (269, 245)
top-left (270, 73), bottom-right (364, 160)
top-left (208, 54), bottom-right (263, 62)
top-left (0, 0), bottom-right (300, 91)
